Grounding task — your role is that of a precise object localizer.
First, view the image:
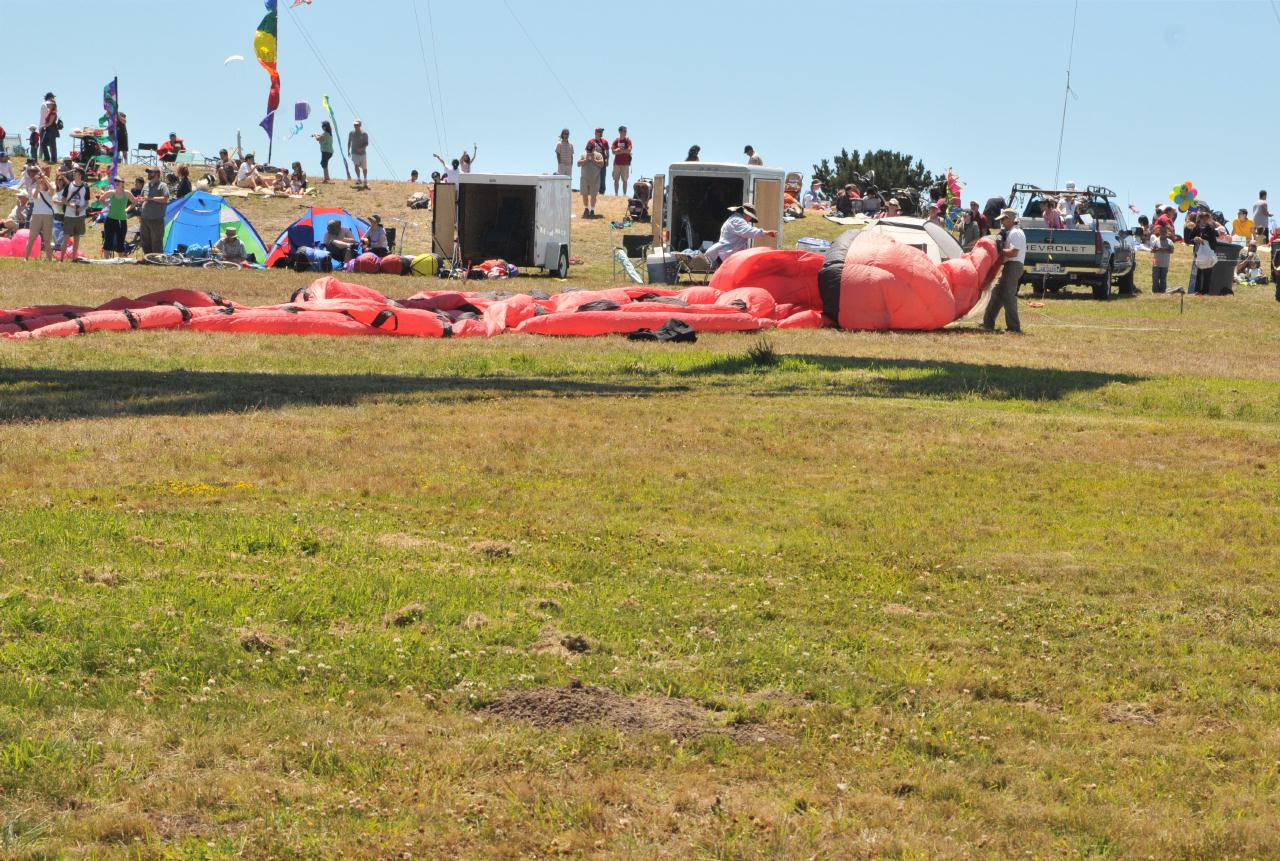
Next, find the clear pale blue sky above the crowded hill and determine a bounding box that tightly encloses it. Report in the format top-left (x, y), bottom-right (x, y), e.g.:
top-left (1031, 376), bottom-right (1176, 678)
top-left (10, 0), bottom-right (1280, 211)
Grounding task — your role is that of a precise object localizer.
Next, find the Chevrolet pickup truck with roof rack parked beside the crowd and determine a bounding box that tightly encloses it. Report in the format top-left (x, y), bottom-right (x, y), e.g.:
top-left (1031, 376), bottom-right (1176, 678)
top-left (1009, 183), bottom-right (1134, 299)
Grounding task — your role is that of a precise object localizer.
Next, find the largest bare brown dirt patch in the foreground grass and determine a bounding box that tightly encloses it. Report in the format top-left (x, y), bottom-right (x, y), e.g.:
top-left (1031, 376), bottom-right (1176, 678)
top-left (485, 684), bottom-right (777, 742)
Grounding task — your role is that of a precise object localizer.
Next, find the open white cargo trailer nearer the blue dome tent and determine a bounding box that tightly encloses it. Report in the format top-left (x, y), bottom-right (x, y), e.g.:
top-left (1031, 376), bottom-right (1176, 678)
top-left (431, 173), bottom-right (572, 278)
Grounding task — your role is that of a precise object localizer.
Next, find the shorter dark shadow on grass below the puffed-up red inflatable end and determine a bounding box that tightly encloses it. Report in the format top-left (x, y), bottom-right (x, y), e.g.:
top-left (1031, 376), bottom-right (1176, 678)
top-left (681, 350), bottom-right (1144, 400)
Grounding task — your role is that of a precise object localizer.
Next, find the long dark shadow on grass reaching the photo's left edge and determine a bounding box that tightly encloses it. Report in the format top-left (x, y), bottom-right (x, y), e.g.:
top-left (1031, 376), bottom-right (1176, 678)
top-left (0, 368), bottom-right (686, 423)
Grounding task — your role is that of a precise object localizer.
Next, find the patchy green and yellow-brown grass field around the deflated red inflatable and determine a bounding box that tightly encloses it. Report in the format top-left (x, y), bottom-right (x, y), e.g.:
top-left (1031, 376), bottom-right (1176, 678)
top-left (0, 176), bottom-right (1280, 860)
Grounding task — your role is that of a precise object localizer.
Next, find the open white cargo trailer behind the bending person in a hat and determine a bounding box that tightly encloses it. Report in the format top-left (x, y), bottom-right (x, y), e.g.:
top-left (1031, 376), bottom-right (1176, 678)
top-left (653, 161), bottom-right (787, 251)
